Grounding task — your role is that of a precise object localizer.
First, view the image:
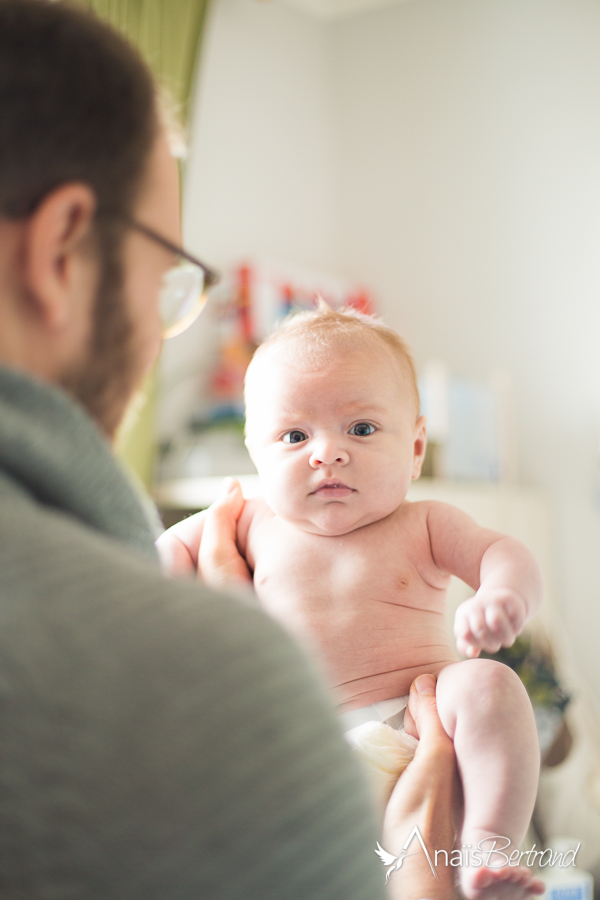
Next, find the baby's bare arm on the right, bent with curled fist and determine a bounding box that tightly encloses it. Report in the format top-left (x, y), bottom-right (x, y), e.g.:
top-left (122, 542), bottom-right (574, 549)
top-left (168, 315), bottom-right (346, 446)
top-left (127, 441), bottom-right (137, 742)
top-left (427, 503), bottom-right (542, 657)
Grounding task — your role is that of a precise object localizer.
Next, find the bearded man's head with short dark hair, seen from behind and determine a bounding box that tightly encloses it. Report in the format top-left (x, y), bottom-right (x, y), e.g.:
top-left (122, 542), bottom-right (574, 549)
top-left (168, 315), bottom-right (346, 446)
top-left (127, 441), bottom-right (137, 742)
top-left (0, 0), bottom-right (179, 435)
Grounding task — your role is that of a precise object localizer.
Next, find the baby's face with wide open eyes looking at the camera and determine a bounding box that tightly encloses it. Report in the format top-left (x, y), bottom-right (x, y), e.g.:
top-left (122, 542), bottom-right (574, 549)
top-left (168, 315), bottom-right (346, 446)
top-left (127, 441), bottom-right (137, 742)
top-left (247, 339), bottom-right (425, 535)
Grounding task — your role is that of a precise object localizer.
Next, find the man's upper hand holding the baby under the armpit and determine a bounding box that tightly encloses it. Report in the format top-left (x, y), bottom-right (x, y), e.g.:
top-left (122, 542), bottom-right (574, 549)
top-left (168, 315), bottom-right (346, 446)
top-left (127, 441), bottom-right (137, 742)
top-left (198, 478), bottom-right (252, 587)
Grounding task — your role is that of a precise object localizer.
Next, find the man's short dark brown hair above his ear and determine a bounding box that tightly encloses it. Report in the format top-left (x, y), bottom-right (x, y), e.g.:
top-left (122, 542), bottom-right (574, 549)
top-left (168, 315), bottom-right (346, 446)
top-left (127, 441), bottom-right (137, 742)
top-left (0, 0), bottom-right (157, 218)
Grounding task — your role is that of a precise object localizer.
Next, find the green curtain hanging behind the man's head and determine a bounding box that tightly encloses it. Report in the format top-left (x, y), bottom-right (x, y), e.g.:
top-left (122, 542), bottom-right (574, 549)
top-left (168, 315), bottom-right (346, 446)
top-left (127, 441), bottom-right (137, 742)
top-left (80, 0), bottom-right (209, 488)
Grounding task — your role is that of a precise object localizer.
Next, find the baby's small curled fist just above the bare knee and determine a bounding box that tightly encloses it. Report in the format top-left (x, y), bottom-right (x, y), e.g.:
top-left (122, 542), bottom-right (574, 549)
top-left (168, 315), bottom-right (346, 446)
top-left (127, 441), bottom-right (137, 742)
top-left (454, 587), bottom-right (527, 659)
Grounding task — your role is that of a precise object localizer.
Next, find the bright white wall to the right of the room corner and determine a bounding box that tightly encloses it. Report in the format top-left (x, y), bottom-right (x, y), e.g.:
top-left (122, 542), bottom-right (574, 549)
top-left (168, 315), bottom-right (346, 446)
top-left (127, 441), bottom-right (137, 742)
top-left (330, 0), bottom-right (600, 698)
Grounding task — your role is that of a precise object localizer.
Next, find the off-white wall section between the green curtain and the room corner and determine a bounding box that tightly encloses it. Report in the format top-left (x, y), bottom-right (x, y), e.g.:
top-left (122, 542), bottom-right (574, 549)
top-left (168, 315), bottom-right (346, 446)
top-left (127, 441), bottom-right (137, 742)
top-left (159, 0), bottom-right (338, 435)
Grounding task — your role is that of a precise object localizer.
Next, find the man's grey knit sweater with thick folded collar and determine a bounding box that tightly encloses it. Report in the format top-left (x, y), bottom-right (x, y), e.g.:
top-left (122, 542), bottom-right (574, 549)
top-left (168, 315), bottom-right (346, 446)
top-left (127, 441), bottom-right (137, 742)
top-left (0, 368), bottom-right (384, 900)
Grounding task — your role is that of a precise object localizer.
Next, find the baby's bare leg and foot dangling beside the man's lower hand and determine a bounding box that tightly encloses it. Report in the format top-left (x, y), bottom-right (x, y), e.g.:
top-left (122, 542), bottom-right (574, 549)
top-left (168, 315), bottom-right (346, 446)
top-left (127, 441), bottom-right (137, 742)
top-left (437, 659), bottom-right (540, 900)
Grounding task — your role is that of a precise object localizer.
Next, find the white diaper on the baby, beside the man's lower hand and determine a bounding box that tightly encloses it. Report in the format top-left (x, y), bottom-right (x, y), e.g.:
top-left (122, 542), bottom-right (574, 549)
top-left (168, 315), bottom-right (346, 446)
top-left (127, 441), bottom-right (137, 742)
top-left (340, 695), bottom-right (418, 808)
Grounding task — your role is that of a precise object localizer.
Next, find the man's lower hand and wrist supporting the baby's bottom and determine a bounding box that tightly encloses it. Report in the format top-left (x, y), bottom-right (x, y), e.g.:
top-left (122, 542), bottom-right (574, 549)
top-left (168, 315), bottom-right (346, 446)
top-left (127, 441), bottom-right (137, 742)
top-left (381, 675), bottom-right (460, 900)
